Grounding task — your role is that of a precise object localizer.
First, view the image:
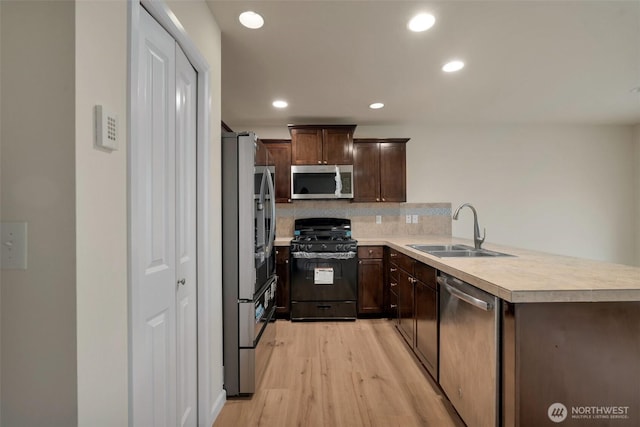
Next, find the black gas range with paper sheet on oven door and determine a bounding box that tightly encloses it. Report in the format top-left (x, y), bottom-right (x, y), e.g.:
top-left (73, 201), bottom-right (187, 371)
top-left (291, 218), bottom-right (358, 320)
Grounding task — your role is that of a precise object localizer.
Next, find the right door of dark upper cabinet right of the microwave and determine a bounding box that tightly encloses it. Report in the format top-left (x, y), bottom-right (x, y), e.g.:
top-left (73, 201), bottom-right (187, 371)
top-left (380, 142), bottom-right (407, 202)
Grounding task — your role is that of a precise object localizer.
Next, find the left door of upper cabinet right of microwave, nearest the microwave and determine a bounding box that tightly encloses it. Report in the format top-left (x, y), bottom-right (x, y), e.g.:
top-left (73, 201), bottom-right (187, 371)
top-left (353, 142), bottom-right (380, 202)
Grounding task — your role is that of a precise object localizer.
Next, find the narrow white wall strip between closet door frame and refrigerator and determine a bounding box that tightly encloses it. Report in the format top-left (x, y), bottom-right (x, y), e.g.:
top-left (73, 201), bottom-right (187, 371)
top-left (167, 0), bottom-right (225, 417)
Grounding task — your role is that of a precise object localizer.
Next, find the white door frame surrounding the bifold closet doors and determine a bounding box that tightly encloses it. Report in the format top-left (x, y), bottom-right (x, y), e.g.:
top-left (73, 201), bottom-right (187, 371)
top-left (127, 0), bottom-right (215, 427)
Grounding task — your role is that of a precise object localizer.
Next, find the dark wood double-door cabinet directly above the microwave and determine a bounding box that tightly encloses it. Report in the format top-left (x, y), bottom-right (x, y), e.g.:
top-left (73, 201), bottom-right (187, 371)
top-left (289, 125), bottom-right (356, 165)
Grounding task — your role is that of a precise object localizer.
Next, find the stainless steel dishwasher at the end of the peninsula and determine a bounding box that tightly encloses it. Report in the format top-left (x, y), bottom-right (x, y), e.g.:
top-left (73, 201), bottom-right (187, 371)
top-left (438, 272), bottom-right (502, 426)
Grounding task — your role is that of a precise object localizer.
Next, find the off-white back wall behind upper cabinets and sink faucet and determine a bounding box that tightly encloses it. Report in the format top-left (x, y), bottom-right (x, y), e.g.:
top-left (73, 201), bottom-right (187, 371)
top-left (250, 124), bottom-right (640, 265)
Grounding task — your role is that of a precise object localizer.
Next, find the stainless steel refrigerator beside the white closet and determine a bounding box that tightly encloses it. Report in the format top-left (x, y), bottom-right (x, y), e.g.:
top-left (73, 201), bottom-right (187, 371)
top-left (222, 132), bottom-right (277, 396)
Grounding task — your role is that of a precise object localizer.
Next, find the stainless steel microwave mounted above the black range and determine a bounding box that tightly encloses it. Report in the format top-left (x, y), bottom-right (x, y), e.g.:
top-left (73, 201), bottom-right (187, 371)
top-left (291, 165), bottom-right (353, 199)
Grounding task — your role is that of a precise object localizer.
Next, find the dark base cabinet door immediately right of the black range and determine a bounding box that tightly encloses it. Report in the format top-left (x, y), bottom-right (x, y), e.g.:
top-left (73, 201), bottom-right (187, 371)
top-left (358, 259), bottom-right (384, 314)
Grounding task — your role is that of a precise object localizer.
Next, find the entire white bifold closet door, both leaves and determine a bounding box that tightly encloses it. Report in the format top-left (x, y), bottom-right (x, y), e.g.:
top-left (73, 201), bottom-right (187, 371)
top-left (130, 8), bottom-right (198, 427)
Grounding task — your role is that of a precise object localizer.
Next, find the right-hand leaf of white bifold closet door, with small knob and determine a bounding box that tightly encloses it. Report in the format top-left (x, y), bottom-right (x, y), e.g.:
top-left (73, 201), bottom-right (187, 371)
top-left (176, 46), bottom-right (198, 427)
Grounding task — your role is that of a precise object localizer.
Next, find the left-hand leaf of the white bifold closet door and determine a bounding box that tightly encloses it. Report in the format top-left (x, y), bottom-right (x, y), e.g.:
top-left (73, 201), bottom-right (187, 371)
top-left (131, 9), bottom-right (176, 426)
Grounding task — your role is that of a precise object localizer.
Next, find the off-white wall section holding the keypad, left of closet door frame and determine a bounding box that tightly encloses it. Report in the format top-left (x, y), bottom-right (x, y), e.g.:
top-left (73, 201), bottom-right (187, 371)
top-left (75, 1), bottom-right (129, 427)
